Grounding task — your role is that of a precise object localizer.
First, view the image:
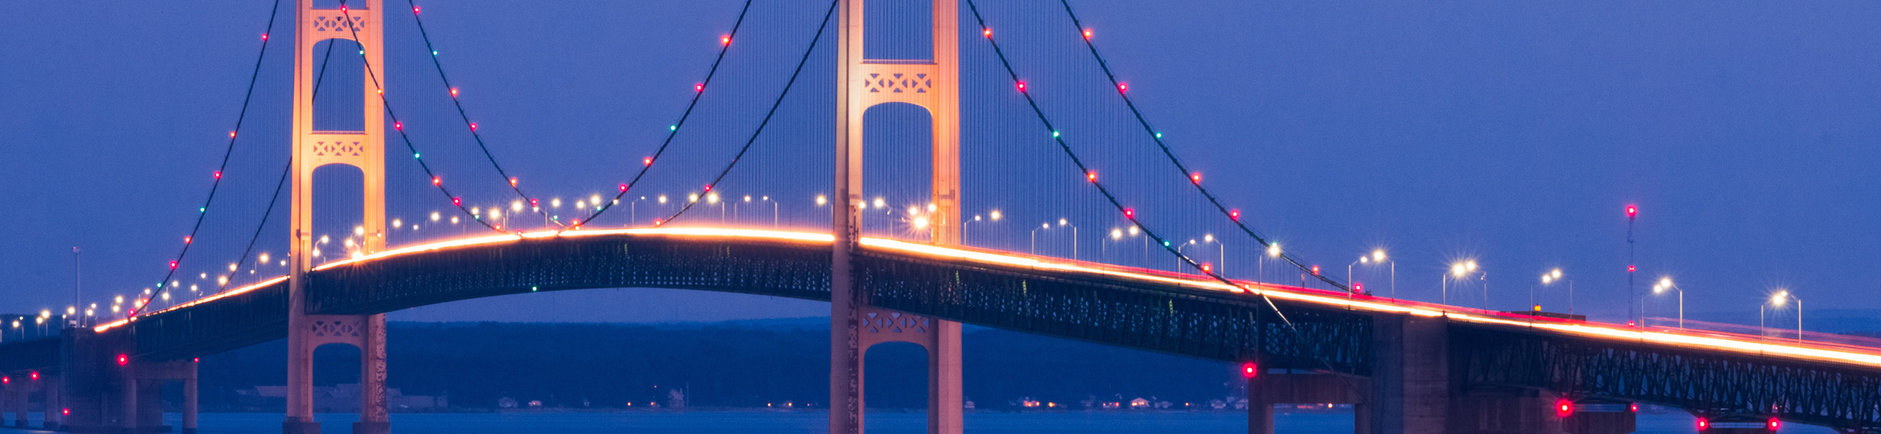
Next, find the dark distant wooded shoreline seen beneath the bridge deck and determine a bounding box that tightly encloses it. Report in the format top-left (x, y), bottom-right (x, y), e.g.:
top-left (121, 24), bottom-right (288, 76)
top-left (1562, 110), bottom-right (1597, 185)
top-left (201, 319), bottom-right (1241, 410)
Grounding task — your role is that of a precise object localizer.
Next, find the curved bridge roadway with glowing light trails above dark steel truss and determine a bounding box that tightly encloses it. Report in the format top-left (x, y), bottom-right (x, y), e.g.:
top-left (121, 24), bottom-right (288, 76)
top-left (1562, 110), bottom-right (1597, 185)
top-left (0, 227), bottom-right (1881, 430)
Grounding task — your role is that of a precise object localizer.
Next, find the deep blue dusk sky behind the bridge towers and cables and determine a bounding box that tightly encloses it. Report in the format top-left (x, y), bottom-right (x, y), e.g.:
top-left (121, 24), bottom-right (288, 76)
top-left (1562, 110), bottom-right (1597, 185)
top-left (0, 0), bottom-right (1881, 329)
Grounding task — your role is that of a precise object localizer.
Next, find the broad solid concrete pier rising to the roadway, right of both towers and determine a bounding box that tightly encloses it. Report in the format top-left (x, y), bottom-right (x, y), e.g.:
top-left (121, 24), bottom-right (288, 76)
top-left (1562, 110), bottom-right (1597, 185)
top-left (1366, 314), bottom-right (1454, 434)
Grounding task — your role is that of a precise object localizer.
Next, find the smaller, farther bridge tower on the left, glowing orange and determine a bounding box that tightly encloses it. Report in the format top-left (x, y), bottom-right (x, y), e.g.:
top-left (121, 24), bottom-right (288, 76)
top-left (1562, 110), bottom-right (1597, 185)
top-left (282, 0), bottom-right (391, 434)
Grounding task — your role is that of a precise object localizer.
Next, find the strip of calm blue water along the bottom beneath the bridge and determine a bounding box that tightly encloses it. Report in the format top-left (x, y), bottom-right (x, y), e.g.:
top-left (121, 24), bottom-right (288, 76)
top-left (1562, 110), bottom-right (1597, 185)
top-left (0, 410), bottom-right (1832, 434)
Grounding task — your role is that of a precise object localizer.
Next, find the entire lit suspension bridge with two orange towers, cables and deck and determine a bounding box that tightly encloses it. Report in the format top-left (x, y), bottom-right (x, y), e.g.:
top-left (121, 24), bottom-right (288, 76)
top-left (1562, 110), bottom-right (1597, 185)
top-left (0, 0), bottom-right (1881, 434)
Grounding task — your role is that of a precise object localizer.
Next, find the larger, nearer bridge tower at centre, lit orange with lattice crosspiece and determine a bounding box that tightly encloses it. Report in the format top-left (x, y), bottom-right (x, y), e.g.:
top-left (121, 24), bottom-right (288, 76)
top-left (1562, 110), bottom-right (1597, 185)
top-left (830, 0), bottom-right (963, 434)
